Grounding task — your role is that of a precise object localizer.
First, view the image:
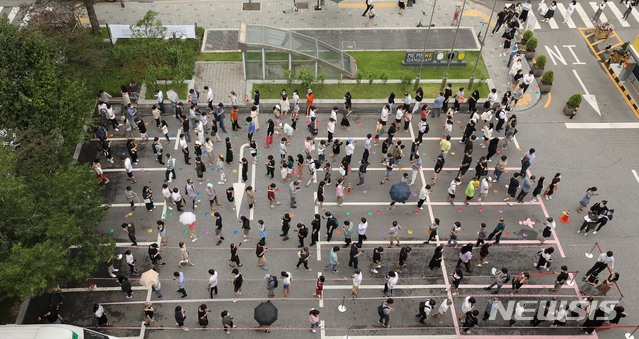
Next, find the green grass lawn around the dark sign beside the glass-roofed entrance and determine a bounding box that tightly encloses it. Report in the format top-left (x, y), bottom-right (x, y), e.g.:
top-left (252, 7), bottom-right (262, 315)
top-left (348, 51), bottom-right (489, 79)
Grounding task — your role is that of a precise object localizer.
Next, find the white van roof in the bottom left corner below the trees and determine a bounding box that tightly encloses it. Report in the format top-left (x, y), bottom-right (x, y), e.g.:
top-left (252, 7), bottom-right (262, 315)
top-left (0, 324), bottom-right (119, 339)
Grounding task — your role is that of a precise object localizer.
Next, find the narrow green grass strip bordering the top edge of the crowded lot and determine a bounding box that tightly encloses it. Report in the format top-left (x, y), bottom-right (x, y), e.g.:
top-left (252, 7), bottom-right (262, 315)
top-left (253, 82), bottom-right (488, 99)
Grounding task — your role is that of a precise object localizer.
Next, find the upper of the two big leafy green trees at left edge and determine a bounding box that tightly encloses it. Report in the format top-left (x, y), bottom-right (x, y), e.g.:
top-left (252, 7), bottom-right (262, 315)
top-left (0, 22), bottom-right (95, 150)
